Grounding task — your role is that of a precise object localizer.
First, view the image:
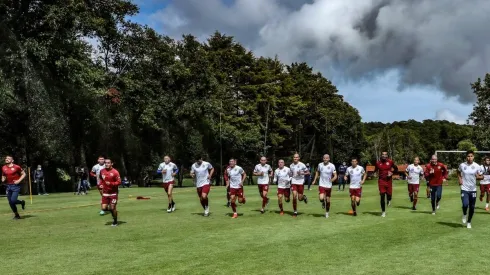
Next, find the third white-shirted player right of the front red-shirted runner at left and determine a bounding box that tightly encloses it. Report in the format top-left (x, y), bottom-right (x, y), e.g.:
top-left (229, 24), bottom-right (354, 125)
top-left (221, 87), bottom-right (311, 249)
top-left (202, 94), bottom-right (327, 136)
top-left (226, 159), bottom-right (247, 219)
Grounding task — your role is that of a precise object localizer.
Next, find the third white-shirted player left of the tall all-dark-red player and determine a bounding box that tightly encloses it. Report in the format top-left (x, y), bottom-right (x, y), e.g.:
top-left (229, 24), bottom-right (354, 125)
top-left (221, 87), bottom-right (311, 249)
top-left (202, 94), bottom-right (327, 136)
top-left (289, 154), bottom-right (310, 217)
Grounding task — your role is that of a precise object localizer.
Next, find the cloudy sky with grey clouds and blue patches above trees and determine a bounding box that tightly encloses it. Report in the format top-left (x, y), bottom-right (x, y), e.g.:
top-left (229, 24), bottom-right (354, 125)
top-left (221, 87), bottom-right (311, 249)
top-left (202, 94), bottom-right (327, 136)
top-left (128, 0), bottom-right (490, 123)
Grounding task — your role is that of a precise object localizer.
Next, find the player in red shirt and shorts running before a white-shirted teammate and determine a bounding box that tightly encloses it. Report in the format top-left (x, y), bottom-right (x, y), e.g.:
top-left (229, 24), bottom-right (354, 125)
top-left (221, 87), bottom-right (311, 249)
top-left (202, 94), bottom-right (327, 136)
top-left (99, 158), bottom-right (121, 226)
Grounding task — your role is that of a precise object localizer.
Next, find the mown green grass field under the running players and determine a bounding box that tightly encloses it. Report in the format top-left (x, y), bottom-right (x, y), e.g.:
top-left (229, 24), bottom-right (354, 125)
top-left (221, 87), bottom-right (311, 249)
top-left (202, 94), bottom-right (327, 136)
top-left (0, 181), bottom-right (490, 275)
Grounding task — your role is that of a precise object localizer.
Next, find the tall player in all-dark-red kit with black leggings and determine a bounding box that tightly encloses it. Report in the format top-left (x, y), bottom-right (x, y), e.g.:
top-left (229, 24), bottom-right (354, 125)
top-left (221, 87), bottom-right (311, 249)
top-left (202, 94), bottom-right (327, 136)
top-left (374, 152), bottom-right (398, 217)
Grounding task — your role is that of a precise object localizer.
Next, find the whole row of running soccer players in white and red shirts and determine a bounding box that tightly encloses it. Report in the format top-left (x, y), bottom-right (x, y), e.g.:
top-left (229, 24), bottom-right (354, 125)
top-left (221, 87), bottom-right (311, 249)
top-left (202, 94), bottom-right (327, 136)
top-left (2, 151), bottom-right (490, 228)
